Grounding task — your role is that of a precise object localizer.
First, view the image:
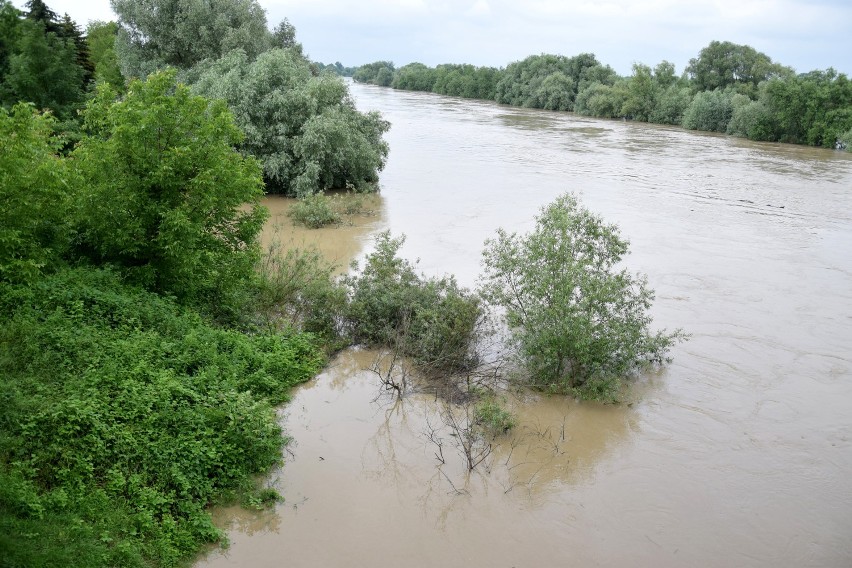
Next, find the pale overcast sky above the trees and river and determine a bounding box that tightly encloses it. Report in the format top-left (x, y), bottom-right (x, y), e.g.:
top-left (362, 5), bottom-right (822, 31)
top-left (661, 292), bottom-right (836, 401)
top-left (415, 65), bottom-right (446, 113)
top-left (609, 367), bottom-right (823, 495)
top-left (14, 0), bottom-right (852, 76)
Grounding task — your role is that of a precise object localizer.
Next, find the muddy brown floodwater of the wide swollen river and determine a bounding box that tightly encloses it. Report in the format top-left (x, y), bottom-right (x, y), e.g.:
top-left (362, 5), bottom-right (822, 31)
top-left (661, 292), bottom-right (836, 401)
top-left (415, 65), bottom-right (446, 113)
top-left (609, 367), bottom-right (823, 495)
top-left (198, 85), bottom-right (852, 568)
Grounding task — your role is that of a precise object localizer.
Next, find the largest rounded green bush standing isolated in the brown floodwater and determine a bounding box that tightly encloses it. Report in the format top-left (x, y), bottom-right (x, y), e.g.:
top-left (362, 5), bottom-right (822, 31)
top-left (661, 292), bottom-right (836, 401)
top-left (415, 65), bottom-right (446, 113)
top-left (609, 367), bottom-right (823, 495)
top-left (483, 195), bottom-right (681, 400)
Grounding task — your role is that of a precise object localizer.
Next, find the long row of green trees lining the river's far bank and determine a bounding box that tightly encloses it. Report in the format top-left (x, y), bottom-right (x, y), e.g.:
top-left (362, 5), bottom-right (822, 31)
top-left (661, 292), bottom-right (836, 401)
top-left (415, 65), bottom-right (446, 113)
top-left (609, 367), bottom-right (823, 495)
top-left (353, 41), bottom-right (852, 149)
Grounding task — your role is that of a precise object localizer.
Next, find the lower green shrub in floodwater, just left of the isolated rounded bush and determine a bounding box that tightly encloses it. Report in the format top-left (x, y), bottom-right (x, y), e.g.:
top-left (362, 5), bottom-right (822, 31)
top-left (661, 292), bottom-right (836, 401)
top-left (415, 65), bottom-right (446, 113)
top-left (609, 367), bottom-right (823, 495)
top-left (346, 232), bottom-right (482, 372)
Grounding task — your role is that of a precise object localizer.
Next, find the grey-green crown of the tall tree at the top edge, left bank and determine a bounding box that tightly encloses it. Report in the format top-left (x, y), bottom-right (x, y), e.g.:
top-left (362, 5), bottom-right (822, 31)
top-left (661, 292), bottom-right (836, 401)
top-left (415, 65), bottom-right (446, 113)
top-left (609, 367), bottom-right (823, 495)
top-left (110, 0), bottom-right (270, 78)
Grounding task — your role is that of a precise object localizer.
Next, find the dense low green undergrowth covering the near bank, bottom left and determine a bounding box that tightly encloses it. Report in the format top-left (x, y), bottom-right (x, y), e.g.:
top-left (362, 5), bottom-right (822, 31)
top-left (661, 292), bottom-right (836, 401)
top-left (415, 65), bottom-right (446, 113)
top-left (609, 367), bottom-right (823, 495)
top-left (0, 268), bottom-right (323, 567)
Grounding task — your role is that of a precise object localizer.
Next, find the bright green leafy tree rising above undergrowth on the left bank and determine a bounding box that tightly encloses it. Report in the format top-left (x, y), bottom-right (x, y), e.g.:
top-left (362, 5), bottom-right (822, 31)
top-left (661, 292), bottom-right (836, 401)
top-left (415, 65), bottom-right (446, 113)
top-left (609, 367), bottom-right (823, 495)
top-left (73, 71), bottom-right (266, 317)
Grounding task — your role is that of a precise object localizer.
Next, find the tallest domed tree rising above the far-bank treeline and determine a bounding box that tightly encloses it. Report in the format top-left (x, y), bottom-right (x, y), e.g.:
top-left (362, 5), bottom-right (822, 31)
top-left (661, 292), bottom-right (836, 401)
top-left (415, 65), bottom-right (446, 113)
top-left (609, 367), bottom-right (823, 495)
top-left (686, 41), bottom-right (792, 98)
